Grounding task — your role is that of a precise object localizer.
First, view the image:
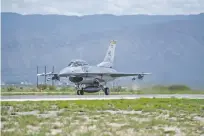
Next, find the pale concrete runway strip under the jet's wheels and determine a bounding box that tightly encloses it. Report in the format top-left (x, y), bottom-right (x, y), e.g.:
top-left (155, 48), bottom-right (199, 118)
top-left (1, 94), bottom-right (204, 101)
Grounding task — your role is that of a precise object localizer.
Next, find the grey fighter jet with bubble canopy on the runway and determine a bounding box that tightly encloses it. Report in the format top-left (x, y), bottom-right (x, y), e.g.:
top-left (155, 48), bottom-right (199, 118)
top-left (37, 40), bottom-right (151, 95)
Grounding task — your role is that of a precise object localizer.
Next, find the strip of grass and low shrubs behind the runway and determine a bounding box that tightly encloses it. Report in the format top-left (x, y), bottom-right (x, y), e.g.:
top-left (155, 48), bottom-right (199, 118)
top-left (1, 85), bottom-right (204, 95)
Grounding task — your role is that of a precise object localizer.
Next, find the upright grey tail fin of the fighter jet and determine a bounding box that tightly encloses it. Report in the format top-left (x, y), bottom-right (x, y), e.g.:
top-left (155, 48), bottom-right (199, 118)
top-left (97, 40), bottom-right (116, 68)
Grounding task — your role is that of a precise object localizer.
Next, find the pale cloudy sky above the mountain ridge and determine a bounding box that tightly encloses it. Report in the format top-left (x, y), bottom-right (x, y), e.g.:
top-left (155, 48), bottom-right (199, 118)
top-left (1, 0), bottom-right (204, 16)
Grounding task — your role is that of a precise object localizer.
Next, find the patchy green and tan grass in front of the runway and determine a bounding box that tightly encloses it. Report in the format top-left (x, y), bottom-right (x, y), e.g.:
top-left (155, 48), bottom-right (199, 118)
top-left (1, 98), bottom-right (204, 136)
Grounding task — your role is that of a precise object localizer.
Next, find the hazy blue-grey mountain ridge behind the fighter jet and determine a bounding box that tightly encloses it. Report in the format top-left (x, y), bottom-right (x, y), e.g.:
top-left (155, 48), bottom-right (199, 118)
top-left (1, 13), bottom-right (204, 88)
